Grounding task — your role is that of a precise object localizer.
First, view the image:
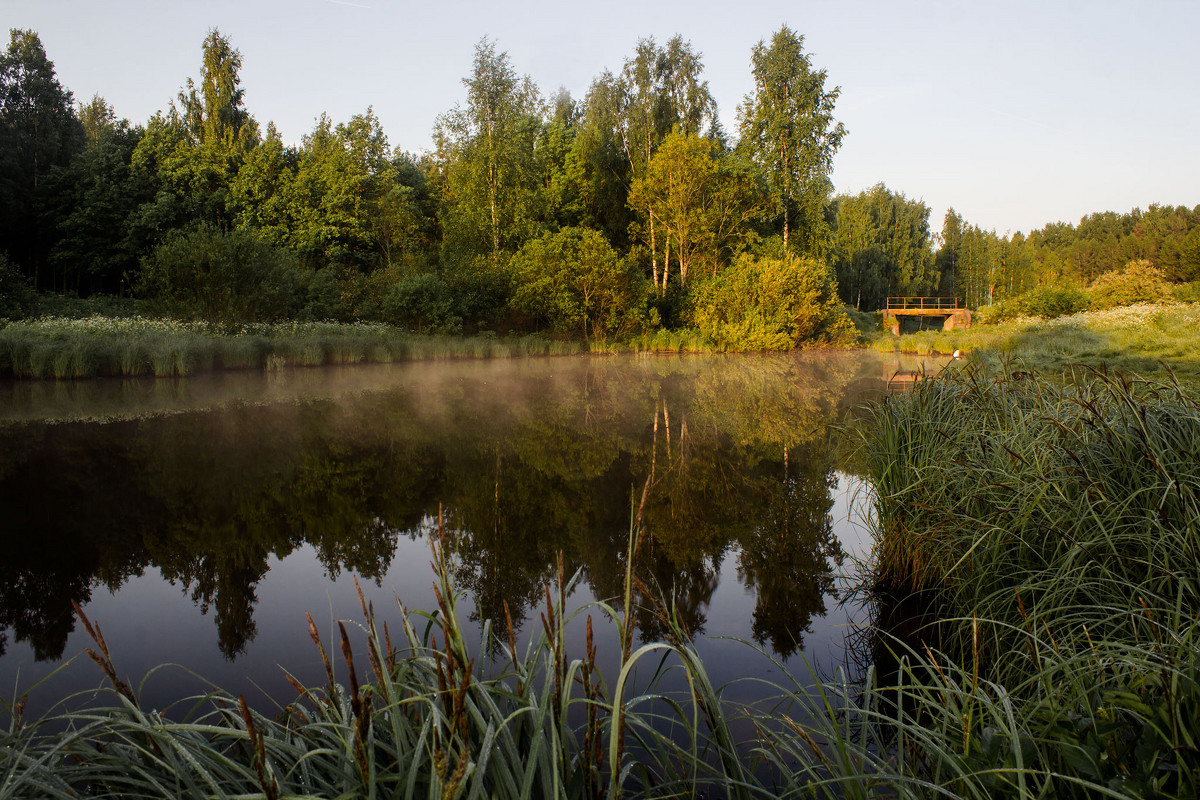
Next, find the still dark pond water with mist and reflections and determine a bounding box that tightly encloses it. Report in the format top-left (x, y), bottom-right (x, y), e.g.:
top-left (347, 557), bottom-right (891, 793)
top-left (0, 353), bottom-right (936, 712)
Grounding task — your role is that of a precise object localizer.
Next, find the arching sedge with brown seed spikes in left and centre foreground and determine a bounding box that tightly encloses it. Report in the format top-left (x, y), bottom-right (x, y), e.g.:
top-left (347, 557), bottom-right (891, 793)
top-left (0, 525), bottom-right (854, 798)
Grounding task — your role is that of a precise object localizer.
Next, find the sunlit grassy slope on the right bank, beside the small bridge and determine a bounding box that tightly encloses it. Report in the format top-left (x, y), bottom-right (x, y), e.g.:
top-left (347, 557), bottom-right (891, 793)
top-left (870, 303), bottom-right (1200, 380)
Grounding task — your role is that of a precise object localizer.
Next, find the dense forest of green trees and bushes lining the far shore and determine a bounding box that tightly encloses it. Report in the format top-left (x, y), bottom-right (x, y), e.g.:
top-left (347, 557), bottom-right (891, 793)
top-left (0, 26), bottom-right (1200, 347)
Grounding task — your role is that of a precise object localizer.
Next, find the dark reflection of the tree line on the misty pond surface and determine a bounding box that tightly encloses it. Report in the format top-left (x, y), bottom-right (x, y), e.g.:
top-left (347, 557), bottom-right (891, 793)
top-left (0, 357), bottom-right (883, 658)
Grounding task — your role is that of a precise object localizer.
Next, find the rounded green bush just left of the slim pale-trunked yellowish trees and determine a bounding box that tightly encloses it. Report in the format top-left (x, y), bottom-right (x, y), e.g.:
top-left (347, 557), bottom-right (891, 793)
top-left (510, 228), bottom-right (642, 339)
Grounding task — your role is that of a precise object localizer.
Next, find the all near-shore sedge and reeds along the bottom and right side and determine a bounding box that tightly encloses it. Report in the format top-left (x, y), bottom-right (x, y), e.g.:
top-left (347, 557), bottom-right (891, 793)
top-left (0, 366), bottom-right (1200, 799)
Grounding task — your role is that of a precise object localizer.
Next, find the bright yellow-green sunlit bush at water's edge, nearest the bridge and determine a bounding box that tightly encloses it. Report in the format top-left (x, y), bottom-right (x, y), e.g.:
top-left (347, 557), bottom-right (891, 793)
top-left (692, 255), bottom-right (853, 350)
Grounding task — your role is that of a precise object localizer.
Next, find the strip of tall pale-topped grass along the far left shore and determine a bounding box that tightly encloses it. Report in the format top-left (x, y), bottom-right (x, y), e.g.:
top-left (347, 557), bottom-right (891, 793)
top-left (0, 315), bottom-right (581, 379)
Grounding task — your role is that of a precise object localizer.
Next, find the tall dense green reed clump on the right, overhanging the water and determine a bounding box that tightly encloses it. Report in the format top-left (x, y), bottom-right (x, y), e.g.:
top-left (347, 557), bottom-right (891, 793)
top-left (862, 371), bottom-right (1200, 796)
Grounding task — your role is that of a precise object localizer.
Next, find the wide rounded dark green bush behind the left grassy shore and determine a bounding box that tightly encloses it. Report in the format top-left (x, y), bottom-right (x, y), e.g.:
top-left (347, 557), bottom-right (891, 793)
top-left (138, 228), bottom-right (302, 325)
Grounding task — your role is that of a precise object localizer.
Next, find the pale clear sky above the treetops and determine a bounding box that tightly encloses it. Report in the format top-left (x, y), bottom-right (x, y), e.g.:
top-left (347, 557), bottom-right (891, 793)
top-left (0, 0), bottom-right (1200, 235)
